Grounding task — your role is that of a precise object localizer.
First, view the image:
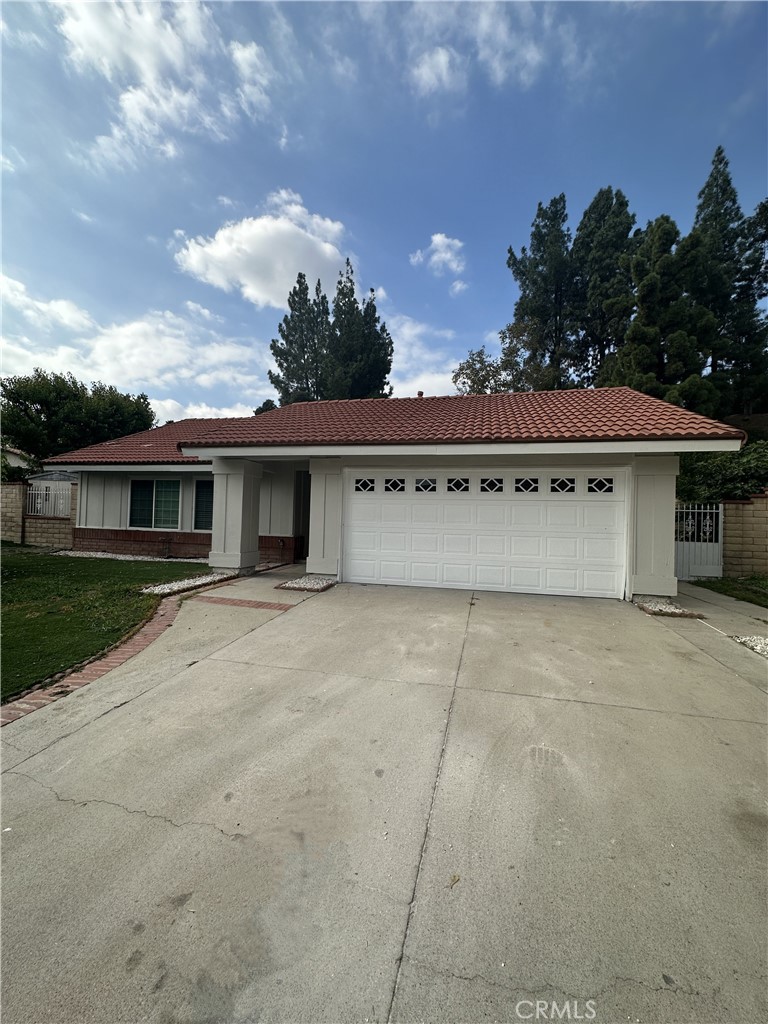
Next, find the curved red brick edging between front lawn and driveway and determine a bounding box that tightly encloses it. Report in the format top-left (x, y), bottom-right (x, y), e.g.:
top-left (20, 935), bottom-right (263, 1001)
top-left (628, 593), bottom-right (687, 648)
top-left (0, 594), bottom-right (181, 728)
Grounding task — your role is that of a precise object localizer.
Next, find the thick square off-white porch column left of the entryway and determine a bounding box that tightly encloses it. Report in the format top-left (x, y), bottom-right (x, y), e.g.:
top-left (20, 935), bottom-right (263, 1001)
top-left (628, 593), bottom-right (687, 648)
top-left (208, 459), bottom-right (262, 569)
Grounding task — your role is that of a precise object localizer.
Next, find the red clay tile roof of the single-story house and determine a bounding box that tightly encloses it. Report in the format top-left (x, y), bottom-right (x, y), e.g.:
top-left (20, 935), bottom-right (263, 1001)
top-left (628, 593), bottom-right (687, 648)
top-left (47, 387), bottom-right (744, 464)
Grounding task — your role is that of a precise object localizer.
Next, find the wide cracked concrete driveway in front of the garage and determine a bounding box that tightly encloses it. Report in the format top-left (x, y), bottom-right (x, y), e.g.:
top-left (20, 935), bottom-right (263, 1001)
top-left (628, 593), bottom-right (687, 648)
top-left (1, 573), bottom-right (768, 1024)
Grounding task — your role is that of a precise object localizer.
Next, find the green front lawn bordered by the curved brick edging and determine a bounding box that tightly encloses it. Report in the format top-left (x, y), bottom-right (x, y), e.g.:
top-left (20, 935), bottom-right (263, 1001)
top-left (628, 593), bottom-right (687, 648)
top-left (0, 544), bottom-right (207, 701)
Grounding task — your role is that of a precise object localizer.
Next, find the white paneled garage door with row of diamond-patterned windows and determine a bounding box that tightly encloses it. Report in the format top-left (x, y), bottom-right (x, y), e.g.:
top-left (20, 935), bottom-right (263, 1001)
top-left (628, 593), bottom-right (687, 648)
top-left (342, 469), bottom-right (626, 598)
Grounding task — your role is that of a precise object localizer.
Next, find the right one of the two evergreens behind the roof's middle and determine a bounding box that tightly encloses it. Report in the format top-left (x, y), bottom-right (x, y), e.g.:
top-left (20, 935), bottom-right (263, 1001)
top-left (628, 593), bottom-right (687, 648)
top-left (326, 260), bottom-right (392, 398)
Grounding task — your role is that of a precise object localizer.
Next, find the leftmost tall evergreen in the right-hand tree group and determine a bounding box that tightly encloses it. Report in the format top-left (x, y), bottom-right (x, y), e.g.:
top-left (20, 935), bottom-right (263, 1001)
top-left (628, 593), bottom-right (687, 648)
top-left (507, 195), bottom-right (573, 389)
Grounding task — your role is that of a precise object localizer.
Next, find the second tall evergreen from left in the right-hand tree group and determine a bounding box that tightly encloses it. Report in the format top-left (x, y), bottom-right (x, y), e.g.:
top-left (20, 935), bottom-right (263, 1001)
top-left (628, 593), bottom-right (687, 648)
top-left (568, 187), bottom-right (635, 386)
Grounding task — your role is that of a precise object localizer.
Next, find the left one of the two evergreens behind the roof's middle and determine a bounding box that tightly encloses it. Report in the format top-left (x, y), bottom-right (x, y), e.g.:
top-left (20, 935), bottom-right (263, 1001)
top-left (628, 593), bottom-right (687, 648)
top-left (268, 273), bottom-right (330, 406)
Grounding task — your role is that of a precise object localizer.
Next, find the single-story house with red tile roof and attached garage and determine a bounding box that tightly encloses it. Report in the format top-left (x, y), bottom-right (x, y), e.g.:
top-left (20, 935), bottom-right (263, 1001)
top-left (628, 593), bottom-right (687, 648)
top-left (47, 387), bottom-right (745, 598)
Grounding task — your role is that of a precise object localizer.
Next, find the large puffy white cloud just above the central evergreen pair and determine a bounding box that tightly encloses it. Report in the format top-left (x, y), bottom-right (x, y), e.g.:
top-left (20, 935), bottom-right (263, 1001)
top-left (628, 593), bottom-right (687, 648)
top-left (175, 188), bottom-right (344, 309)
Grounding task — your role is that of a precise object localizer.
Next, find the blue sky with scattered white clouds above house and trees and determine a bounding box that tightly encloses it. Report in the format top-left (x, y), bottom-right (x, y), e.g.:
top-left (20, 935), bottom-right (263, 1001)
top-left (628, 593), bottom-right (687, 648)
top-left (1, 0), bottom-right (768, 422)
